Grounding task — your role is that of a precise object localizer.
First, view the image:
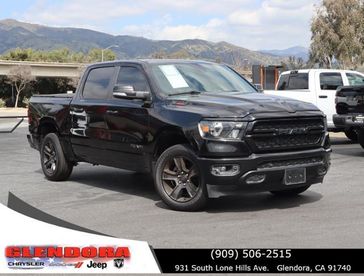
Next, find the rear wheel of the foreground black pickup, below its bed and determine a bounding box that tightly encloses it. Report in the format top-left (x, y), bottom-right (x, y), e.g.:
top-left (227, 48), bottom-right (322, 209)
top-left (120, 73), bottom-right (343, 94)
top-left (40, 133), bottom-right (73, 181)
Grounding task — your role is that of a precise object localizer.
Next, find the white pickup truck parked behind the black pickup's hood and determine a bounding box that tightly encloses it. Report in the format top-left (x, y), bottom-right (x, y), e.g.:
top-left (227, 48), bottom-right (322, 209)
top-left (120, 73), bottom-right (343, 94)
top-left (264, 69), bottom-right (364, 141)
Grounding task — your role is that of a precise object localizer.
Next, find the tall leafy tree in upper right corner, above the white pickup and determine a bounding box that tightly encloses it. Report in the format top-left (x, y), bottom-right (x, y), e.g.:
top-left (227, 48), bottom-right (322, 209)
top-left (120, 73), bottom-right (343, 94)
top-left (310, 0), bottom-right (364, 69)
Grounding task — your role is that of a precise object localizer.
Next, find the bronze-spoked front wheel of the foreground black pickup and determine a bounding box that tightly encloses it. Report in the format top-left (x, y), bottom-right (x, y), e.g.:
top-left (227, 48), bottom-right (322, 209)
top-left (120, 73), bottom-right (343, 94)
top-left (154, 145), bottom-right (207, 211)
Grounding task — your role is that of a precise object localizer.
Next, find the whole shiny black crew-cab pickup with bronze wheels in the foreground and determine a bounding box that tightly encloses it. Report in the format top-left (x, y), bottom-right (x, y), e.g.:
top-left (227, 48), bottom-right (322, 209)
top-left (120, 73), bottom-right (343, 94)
top-left (28, 60), bottom-right (331, 211)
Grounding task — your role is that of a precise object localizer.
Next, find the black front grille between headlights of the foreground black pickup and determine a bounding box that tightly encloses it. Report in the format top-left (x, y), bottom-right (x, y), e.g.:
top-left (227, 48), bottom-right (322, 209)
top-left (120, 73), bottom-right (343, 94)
top-left (245, 117), bottom-right (325, 152)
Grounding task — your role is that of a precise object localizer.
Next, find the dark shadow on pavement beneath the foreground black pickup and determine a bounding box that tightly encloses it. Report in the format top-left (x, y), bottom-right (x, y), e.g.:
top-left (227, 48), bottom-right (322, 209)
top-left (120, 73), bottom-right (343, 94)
top-left (39, 167), bottom-right (322, 213)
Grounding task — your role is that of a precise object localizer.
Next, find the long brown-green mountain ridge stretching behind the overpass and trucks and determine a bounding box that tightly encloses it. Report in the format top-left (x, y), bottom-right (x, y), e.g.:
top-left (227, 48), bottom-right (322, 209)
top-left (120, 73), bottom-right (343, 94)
top-left (0, 19), bottom-right (302, 66)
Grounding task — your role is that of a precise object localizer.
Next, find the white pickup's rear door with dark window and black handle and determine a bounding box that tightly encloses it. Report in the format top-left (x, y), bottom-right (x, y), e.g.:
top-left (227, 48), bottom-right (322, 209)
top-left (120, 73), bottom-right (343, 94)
top-left (316, 72), bottom-right (344, 128)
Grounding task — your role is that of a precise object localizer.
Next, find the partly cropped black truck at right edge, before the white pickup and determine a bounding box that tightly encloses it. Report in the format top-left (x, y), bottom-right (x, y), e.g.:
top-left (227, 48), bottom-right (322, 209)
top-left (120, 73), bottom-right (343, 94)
top-left (333, 85), bottom-right (364, 148)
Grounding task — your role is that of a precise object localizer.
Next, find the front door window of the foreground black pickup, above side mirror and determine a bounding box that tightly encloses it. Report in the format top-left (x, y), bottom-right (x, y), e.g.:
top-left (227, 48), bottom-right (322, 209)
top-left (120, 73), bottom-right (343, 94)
top-left (116, 66), bottom-right (149, 91)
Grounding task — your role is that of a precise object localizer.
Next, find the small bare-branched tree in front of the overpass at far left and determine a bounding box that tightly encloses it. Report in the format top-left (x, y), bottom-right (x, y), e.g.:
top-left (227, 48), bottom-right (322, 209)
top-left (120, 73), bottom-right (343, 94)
top-left (8, 65), bottom-right (35, 107)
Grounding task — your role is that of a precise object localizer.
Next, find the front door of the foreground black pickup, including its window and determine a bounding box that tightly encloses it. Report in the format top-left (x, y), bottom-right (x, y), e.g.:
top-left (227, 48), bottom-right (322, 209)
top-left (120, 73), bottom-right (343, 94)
top-left (105, 64), bottom-right (152, 171)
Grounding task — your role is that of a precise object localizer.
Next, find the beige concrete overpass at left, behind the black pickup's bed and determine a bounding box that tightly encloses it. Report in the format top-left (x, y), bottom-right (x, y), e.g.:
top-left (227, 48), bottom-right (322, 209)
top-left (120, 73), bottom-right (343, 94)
top-left (0, 60), bottom-right (85, 78)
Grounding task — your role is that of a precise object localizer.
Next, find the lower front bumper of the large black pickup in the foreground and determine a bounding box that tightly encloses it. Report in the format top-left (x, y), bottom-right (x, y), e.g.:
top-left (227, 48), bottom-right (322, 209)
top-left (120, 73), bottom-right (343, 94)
top-left (199, 148), bottom-right (331, 195)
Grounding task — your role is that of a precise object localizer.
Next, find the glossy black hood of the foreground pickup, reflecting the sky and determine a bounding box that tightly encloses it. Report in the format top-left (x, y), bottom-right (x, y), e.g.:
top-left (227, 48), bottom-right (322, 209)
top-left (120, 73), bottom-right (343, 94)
top-left (167, 93), bottom-right (319, 117)
